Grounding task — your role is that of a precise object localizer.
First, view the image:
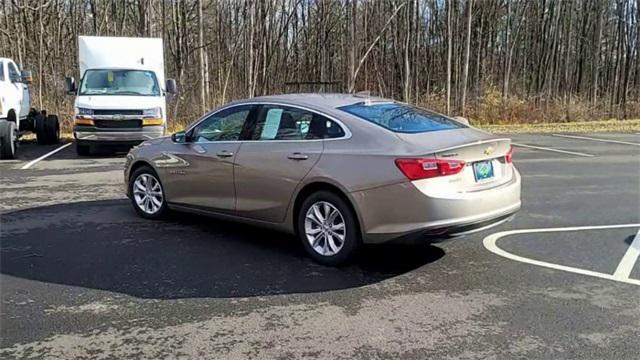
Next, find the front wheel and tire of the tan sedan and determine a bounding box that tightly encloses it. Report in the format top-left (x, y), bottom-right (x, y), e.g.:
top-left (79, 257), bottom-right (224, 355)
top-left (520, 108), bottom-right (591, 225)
top-left (128, 166), bottom-right (168, 220)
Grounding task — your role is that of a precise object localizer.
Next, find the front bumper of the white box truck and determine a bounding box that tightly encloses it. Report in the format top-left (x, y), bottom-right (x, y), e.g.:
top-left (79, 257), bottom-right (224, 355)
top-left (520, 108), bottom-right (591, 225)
top-left (73, 126), bottom-right (165, 144)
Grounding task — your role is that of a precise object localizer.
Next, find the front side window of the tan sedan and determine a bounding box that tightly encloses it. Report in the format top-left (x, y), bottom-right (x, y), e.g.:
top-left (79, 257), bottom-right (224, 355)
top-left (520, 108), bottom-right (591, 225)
top-left (189, 105), bottom-right (253, 143)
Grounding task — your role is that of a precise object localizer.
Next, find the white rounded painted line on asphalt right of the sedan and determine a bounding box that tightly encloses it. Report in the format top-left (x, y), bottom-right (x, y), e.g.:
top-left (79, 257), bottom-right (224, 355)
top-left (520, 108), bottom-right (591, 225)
top-left (482, 224), bottom-right (640, 286)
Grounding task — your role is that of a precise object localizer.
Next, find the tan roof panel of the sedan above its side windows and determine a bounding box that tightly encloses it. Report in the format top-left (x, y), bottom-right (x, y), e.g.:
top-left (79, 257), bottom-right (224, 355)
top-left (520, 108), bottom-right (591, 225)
top-left (239, 93), bottom-right (393, 110)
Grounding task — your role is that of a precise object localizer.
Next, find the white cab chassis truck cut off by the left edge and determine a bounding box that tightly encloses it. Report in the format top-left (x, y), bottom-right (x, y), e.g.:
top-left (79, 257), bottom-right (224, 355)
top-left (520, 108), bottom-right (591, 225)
top-left (0, 57), bottom-right (60, 159)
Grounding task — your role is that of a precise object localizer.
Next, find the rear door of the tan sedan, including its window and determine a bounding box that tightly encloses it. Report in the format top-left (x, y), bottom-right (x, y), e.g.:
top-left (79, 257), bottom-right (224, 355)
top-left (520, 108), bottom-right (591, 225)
top-left (235, 104), bottom-right (323, 223)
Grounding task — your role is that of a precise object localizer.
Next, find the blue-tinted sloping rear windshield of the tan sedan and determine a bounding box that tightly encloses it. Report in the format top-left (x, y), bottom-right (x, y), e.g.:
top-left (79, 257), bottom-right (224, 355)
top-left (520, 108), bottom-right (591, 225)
top-left (339, 103), bottom-right (467, 133)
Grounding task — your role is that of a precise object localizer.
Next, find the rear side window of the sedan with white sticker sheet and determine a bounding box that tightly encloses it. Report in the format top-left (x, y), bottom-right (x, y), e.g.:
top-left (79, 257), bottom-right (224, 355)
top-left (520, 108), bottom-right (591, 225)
top-left (250, 105), bottom-right (344, 140)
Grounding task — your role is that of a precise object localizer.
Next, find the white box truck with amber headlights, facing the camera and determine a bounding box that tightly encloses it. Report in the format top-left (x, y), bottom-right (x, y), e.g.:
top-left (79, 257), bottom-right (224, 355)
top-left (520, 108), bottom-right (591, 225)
top-left (65, 36), bottom-right (176, 155)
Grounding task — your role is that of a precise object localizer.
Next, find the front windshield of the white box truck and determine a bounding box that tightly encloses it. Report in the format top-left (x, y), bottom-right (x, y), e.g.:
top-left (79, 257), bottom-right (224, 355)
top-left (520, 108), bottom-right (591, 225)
top-left (79, 70), bottom-right (160, 96)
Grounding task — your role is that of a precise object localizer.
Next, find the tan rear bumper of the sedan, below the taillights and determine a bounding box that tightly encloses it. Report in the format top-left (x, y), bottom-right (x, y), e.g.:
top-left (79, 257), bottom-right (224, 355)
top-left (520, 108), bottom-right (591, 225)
top-left (351, 167), bottom-right (521, 243)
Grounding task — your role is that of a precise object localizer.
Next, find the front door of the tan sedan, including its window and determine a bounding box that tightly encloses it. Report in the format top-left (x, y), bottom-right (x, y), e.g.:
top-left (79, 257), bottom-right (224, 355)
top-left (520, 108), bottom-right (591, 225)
top-left (160, 105), bottom-right (254, 212)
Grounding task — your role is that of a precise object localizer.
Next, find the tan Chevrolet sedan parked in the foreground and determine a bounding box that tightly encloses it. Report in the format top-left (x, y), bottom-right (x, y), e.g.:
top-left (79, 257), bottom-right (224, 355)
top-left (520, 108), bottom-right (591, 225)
top-left (125, 94), bottom-right (520, 265)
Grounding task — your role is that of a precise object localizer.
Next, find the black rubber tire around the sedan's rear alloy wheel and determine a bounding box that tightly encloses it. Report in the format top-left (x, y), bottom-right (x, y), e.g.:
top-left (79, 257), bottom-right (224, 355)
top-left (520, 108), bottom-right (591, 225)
top-left (297, 191), bottom-right (361, 266)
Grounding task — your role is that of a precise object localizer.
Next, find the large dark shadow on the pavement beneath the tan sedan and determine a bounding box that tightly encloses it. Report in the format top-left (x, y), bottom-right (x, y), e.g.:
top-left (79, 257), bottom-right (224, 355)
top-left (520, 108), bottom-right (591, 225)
top-left (0, 200), bottom-right (444, 299)
